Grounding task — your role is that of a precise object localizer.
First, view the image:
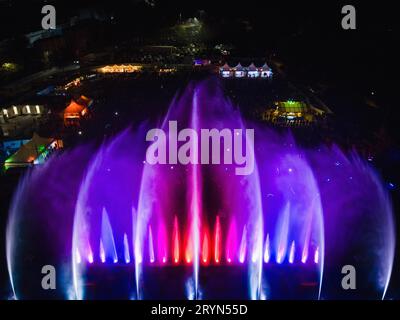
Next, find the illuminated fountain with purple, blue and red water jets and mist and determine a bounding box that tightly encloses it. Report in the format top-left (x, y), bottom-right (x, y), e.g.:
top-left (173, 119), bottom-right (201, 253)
top-left (7, 81), bottom-right (394, 299)
